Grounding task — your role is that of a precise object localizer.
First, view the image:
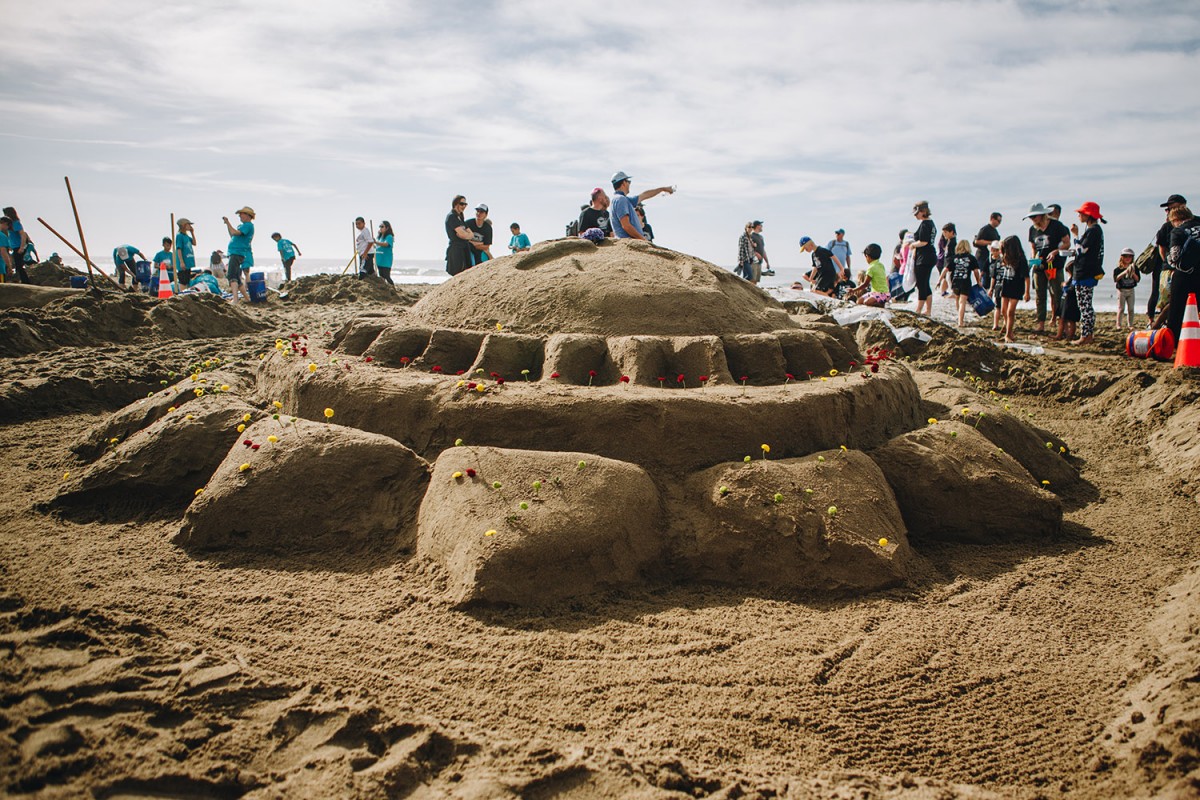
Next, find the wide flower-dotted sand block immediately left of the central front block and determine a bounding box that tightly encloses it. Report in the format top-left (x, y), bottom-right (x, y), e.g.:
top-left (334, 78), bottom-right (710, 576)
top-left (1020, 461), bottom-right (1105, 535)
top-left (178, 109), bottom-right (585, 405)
top-left (174, 419), bottom-right (428, 553)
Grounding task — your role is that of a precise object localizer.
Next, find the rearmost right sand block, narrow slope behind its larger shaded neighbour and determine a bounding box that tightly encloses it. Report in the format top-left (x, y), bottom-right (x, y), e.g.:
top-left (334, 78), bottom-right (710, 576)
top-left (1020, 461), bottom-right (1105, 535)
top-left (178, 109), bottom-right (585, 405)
top-left (912, 369), bottom-right (1080, 492)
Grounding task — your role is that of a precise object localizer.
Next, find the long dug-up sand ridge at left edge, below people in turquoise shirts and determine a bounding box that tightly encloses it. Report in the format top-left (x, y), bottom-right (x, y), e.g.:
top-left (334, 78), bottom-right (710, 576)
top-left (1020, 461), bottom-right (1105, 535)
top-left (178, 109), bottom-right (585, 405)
top-left (0, 289), bottom-right (263, 356)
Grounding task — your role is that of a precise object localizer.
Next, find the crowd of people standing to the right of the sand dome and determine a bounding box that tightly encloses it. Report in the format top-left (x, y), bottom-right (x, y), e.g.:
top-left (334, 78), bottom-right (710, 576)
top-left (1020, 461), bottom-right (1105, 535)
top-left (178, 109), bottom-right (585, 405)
top-left (768, 194), bottom-right (1200, 344)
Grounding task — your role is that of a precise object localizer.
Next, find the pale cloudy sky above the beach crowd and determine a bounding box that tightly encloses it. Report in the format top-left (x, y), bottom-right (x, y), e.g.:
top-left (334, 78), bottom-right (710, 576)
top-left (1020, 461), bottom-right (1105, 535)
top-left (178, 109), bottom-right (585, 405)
top-left (0, 0), bottom-right (1200, 272)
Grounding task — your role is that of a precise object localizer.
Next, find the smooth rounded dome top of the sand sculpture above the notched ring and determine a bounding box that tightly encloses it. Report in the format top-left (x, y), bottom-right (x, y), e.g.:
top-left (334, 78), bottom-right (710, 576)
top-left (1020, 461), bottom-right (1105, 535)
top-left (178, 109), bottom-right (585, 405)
top-left (412, 239), bottom-right (796, 336)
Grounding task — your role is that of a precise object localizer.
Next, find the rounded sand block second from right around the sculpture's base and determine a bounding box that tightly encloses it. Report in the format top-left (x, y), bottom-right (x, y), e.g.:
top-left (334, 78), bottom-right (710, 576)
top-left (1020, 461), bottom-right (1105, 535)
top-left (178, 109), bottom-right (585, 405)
top-left (871, 422), bottom-right (1062, 545)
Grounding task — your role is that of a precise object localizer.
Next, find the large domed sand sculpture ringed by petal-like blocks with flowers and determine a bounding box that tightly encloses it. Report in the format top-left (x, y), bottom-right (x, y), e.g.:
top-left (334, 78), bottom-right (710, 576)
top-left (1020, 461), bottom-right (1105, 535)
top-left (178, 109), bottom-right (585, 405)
top-left (56, 240), bottom-right (1074, 604)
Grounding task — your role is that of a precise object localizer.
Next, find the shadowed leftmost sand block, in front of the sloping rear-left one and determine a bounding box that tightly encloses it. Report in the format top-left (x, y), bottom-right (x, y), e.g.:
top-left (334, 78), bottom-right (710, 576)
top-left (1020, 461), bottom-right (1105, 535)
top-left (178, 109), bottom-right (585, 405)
top-left (52, 395), bottom-right (265, 511)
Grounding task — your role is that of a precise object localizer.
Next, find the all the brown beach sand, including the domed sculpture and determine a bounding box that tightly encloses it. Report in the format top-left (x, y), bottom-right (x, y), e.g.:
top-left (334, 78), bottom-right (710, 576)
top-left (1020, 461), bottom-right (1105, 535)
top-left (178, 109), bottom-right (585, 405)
top-left (0, 241), bottom-right (1200, 800)
